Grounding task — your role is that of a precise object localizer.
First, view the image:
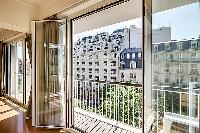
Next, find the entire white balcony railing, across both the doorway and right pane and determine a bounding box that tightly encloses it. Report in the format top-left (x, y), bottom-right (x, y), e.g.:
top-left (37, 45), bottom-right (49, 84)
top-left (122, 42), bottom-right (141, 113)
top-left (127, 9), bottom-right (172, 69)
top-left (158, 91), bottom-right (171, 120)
top-left (74, 80), bottom-right (200, 132)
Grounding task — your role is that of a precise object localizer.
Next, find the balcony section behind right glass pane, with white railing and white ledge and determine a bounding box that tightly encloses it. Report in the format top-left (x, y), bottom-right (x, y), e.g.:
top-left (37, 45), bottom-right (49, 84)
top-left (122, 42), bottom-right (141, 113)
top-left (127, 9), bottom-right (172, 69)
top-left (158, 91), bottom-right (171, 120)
top-left (153, 86), bottom-right (200, 132)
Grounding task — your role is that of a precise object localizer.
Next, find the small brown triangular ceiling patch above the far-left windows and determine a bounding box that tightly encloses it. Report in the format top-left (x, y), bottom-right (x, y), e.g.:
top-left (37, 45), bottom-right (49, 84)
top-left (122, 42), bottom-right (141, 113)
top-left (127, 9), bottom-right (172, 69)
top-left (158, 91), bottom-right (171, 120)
top-left (0, 28), bottom-right (20, 41)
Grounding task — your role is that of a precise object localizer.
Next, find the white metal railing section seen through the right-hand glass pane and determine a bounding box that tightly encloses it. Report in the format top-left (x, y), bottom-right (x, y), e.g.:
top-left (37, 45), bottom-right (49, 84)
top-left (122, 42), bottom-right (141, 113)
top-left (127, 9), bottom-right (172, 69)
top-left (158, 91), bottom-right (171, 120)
top-left (153, 87), bottom-right (200, 119)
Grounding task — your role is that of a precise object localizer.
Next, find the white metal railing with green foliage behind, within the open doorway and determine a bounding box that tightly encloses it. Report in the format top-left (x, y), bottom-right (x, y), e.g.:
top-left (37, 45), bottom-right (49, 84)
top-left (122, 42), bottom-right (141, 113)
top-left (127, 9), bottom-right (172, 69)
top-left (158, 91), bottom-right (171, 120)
top-left (74, 80), bottom-right (142, 128)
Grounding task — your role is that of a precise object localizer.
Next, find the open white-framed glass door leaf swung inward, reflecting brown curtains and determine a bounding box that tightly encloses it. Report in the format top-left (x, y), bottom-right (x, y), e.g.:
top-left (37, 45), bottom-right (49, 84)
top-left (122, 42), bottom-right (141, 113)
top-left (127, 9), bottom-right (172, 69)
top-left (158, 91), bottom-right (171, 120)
top-left (32, 21), bottom-right (66, 127)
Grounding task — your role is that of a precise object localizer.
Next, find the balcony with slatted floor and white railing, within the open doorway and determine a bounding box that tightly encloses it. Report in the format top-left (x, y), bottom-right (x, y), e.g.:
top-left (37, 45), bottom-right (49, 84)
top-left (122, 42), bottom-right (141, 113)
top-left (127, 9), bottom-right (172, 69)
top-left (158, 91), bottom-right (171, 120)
top-left (74, 80), bottom-right (142, 133)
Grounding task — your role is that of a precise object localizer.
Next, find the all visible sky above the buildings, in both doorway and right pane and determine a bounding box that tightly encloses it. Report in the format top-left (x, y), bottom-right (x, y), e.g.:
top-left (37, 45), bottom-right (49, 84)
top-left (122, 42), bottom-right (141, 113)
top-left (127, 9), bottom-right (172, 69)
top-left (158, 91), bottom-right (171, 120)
top-left (74, 2), bottom-right (200, 41)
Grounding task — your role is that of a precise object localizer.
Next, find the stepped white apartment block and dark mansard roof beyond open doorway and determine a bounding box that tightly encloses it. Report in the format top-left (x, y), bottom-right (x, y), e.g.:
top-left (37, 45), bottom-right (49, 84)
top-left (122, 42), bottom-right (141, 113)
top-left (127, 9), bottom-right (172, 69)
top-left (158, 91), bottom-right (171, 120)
top-left (73, 25), bottom-right (171, 84)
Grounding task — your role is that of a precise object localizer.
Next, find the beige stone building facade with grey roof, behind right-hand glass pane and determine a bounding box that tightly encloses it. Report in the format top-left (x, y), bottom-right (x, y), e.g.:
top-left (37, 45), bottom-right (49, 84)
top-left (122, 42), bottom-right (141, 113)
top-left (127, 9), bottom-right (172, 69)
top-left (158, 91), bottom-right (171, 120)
top-left (152, 37), bottom-right (200, 88)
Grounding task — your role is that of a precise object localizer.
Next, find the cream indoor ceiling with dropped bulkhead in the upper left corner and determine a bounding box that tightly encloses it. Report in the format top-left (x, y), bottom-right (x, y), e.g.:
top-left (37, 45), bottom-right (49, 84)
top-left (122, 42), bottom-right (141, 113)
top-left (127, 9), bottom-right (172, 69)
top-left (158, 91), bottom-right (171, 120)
top-left (0, 0), bottom-right (85, 33)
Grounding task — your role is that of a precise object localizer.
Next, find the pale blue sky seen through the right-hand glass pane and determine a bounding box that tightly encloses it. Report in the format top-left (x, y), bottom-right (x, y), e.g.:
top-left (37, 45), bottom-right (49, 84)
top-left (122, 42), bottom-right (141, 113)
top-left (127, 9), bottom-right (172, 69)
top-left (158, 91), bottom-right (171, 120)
top-left (152, 2), bottom-right (200, 40)
